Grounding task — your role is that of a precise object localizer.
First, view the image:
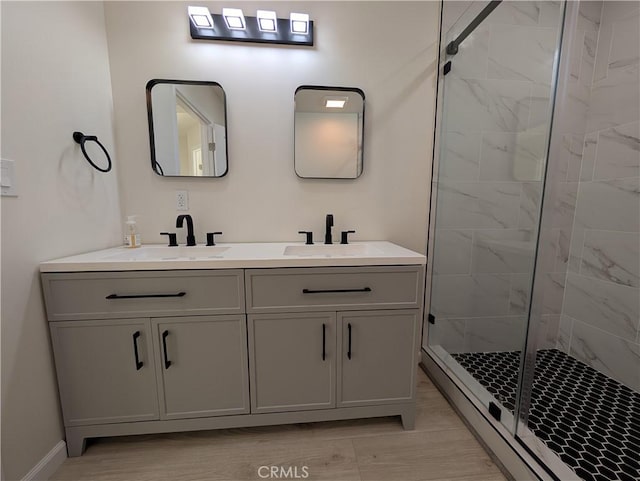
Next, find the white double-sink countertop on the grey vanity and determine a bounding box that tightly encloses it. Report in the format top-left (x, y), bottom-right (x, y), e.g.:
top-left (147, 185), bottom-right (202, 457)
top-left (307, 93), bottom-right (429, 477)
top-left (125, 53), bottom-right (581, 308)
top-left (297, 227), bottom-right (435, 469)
top-left (40, 241), bottom-right (426, 272)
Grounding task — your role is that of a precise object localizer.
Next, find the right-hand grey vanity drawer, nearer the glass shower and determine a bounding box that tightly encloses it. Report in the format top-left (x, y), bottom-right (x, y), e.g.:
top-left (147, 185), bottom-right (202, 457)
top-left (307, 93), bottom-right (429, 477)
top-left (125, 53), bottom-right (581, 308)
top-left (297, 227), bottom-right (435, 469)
top-left (246, 266), bottom-right (424, 312)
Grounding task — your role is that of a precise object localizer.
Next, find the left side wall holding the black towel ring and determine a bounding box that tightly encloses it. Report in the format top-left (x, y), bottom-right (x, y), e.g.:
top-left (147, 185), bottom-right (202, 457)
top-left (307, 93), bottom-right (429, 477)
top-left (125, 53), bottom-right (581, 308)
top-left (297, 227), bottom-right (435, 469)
top-left (1, 1), bottom-right (122, 480)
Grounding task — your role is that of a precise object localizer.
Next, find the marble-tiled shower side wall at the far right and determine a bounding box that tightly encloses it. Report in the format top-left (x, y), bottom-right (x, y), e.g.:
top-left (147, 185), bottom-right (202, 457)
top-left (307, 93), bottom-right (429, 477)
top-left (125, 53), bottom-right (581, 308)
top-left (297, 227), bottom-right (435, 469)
top-left (556, 1), bottom-right (640, 391)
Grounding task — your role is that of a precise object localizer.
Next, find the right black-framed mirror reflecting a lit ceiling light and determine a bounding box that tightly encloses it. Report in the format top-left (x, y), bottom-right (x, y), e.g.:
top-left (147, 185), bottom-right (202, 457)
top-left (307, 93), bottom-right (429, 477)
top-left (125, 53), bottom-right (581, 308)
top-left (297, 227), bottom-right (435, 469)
top-left (294, 85), bottom-right (364, 179)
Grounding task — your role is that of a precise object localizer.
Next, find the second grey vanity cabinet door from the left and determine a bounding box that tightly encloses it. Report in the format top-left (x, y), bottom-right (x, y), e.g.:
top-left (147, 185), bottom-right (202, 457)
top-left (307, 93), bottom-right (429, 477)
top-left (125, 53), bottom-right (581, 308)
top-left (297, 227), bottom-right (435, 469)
top-left (152, 316), bottom-right (249, 419)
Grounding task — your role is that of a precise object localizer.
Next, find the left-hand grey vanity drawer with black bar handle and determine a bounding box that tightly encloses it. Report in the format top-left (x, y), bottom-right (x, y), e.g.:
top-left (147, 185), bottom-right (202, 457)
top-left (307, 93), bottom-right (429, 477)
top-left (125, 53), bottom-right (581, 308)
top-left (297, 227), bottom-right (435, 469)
top-left (42, 270), bottom-right (244, 321)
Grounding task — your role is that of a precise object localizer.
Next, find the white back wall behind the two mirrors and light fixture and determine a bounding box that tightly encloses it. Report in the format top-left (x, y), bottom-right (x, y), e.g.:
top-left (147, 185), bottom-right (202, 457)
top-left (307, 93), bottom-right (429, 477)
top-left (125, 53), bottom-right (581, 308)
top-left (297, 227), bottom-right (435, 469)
top-left (105, 1), bottom-right (439, 251)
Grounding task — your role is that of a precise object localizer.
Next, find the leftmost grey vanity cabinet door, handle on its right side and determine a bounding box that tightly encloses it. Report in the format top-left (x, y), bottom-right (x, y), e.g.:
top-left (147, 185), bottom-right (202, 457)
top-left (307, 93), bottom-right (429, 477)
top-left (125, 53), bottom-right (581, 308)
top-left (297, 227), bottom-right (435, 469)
top-left (49, 319), bottom-right (158, 426)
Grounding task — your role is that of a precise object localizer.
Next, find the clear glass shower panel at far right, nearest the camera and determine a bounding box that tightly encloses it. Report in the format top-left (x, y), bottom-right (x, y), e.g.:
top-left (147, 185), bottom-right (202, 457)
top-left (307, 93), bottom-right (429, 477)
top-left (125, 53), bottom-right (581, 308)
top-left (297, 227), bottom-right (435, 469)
top-left (517, 1), bottom-right (640, 481)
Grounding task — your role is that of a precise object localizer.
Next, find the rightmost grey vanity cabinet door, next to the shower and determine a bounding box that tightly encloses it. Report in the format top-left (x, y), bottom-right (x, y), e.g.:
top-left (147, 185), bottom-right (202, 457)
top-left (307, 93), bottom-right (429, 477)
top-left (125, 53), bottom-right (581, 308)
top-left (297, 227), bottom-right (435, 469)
top-left (338, 309), bottom-right (419, 407)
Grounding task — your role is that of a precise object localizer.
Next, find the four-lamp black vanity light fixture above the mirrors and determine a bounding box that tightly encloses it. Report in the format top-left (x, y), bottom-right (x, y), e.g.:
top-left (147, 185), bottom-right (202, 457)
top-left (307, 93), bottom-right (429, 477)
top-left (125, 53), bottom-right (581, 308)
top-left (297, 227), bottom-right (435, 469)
top-left (188, 7), bottom-right (313, 46)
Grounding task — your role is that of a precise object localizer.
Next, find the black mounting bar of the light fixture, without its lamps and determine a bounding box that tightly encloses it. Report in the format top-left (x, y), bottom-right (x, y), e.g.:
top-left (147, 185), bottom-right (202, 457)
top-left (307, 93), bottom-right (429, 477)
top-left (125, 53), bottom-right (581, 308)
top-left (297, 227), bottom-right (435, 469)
top-left (189, 13), bottom-right (313, 46)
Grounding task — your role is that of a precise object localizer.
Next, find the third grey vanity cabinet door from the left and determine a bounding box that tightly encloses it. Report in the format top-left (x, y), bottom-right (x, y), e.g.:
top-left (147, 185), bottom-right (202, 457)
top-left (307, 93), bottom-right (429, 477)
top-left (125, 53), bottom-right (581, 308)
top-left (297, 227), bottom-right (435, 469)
top-left (248, 312), bottom-right (336, 413)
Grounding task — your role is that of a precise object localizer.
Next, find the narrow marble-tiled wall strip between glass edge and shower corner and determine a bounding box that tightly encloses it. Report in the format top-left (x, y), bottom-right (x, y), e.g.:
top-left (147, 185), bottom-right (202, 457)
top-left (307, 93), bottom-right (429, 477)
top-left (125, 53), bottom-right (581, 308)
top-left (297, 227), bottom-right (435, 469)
top-left (536, 1), bottom-right (603, 349)
